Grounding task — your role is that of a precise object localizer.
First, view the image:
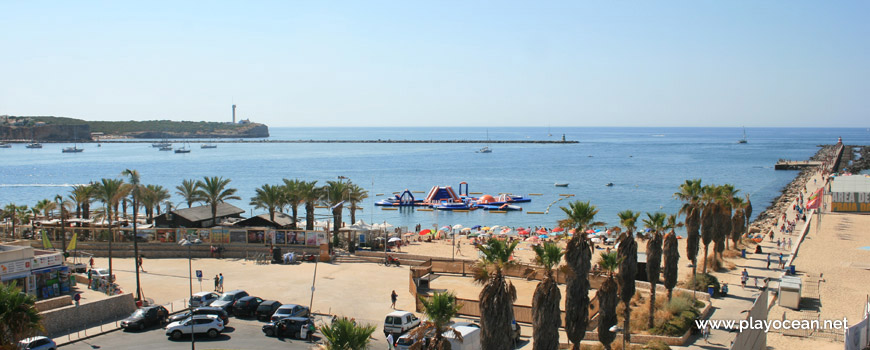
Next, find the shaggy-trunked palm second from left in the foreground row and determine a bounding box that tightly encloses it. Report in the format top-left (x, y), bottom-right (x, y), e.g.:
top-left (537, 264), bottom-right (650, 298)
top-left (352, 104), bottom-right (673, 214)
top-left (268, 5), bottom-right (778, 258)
top-left (532, 242), bottom-right (565, 350)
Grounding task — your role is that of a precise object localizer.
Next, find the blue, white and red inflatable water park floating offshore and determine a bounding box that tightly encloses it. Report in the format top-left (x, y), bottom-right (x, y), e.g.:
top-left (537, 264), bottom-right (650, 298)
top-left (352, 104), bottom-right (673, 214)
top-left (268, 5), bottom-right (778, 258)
top-left (375, 182), bottom-right (532, 211)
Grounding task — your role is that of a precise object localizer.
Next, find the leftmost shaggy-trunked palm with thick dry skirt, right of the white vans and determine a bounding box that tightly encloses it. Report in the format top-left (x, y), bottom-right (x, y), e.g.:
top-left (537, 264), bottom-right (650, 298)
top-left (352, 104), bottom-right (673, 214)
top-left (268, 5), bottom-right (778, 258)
top-left (474, 238), bottom-right (519, 350)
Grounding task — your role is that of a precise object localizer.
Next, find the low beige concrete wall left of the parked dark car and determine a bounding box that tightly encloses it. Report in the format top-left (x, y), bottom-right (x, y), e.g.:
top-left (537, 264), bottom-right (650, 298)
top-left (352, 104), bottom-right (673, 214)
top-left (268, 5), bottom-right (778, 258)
top-left (40, 293), bottom-right (136, 337)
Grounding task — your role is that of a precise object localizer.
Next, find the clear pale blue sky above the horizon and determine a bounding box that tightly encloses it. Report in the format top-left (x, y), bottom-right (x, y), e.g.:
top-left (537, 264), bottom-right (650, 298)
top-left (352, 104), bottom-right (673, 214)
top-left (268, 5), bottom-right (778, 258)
top-left (0, 1), bottom-right (870, 127)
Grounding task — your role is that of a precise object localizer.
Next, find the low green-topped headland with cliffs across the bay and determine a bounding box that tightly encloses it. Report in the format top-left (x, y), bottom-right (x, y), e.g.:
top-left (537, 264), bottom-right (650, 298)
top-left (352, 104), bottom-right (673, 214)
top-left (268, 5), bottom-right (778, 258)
top-left (0, 116), bottom-right (269, 141)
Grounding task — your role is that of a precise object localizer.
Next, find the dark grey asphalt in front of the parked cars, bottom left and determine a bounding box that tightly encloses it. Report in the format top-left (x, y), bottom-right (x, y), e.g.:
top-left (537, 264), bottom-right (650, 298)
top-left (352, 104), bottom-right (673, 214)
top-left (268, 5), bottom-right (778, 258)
top-left (62, 318), bottom-right (312, 350)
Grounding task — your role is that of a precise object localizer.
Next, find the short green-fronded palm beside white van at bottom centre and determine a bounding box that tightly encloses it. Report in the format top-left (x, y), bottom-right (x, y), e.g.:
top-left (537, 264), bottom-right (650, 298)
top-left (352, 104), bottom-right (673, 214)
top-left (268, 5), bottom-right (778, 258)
top-left (410, 292), bottom-right (462, 350)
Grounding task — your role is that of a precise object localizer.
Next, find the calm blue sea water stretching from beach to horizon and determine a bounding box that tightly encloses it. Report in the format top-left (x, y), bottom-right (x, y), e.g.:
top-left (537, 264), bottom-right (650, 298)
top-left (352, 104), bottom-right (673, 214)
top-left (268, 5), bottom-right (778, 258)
top-left (0, 127), bottom-right (870, 234)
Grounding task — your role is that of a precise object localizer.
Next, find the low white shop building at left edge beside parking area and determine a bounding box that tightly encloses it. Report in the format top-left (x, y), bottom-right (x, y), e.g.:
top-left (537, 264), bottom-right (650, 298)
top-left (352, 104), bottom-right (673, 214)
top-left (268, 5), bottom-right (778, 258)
top-left (0, 245), bottom-right (71, 299)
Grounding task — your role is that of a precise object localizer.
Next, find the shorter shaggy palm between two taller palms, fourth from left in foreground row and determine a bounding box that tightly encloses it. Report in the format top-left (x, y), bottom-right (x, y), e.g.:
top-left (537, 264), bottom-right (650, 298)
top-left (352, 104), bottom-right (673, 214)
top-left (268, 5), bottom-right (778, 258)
top-left (598, 252), bottom-right (634, 350)
